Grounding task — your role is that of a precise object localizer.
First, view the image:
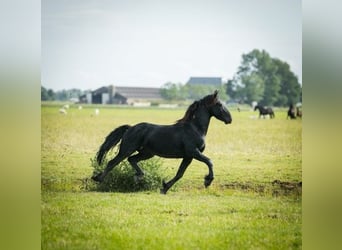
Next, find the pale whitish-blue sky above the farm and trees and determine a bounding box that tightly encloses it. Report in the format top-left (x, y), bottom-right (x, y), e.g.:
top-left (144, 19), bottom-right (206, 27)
top-left (41, 0), bottom-right (302, 90)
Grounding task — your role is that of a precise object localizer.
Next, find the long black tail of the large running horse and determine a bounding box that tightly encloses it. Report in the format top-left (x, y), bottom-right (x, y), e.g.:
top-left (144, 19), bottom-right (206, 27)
top-left (96, 125), bottom-right (131, 165)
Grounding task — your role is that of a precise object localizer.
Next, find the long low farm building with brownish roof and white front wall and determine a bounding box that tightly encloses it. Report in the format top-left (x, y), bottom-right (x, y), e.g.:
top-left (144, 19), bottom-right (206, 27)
top-left (80, 85), bottom-right (162, 104)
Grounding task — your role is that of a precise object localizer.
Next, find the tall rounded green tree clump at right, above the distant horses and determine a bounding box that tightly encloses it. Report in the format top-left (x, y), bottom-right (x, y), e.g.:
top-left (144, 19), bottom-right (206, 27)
top-left (226, 49), bottom-right (300, 106)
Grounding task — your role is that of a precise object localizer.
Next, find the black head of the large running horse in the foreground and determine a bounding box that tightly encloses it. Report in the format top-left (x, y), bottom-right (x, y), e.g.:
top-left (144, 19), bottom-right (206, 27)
top-left (206, 90), bottom-right (232, 124)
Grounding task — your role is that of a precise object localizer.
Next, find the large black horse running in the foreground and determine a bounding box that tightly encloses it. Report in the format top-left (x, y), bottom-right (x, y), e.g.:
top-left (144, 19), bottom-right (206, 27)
top-left (92, 91), bottom-right (232, 194)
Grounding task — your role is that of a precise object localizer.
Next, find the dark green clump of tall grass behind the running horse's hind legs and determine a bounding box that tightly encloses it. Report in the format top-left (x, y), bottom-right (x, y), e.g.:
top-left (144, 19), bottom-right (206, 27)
top-left (82, 158), bottom-right (163, 192)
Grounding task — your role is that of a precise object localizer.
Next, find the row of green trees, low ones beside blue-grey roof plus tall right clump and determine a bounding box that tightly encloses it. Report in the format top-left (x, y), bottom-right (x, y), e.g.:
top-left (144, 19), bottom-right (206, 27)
top-left (161, 49), bottom-right (302, 106)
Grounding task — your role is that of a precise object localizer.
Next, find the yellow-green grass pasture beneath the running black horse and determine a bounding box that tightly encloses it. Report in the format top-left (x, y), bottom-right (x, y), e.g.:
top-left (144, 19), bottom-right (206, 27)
top-left (41, 104), bottom-right (302, 249)
